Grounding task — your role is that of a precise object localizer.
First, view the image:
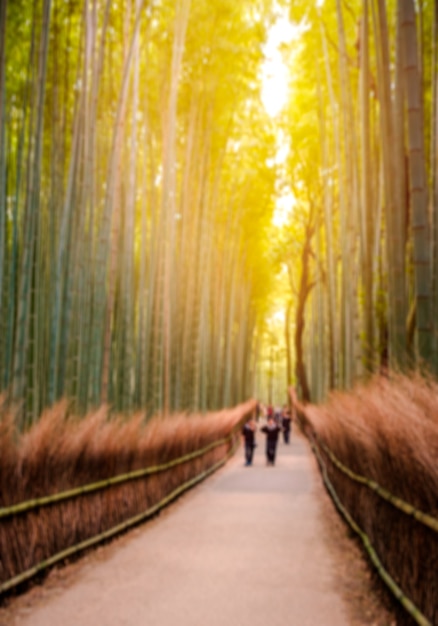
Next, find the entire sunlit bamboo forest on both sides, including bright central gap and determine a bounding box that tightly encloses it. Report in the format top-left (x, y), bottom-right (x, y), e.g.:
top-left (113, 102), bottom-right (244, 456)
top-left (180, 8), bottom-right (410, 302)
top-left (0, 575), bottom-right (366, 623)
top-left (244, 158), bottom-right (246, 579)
top-left (0, 0), bottom-right (438, 420)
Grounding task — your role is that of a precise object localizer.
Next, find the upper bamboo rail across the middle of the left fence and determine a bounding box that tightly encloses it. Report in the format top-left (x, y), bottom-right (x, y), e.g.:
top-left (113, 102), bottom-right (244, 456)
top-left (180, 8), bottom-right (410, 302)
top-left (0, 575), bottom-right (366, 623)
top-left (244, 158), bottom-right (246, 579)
top-left (0, 429), bottom-right (231, 519)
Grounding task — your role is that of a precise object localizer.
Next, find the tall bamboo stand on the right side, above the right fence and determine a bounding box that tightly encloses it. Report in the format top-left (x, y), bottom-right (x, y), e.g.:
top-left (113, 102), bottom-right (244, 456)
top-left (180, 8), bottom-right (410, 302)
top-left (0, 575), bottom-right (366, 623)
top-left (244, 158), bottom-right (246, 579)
top-left (283, 0), bottom-right (438, 400)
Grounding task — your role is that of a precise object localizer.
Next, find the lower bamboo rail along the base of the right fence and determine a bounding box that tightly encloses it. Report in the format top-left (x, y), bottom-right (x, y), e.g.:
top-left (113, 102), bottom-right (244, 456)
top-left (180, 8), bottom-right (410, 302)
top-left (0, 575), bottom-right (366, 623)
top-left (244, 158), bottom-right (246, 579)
top-left (310, 440), bottom-right (433, 626)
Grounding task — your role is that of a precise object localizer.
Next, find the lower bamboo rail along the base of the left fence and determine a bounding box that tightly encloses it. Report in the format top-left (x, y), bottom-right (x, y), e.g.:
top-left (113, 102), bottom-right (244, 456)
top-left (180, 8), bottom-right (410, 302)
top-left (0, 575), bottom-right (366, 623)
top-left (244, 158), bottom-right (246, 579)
top-left (0, 432), bottom-right (239, 595)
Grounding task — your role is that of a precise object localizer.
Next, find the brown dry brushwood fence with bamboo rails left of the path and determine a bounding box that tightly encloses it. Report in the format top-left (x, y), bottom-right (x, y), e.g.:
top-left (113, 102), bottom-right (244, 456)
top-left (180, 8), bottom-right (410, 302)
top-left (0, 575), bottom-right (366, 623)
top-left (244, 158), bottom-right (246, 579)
top-left (0, 401), bottom-right (255, 595)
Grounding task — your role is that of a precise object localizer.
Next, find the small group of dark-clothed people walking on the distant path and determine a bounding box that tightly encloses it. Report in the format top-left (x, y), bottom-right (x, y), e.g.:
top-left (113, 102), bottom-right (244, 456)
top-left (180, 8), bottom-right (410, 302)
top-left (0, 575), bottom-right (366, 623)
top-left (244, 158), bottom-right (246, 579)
top-left (242, 406), bottom-right (292, 466)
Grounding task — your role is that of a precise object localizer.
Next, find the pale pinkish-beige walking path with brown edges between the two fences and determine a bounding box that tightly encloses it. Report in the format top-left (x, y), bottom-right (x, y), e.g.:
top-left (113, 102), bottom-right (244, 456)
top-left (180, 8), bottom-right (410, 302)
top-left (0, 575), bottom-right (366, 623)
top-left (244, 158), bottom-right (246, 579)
top-left (0, 433), bottom-right (396, 626)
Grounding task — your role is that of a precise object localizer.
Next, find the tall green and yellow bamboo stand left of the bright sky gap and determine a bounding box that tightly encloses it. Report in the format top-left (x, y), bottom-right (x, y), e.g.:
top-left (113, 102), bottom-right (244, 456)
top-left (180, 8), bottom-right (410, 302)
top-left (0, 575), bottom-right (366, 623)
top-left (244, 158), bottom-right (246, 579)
top-left (0, 0), bottom-right (276, 424)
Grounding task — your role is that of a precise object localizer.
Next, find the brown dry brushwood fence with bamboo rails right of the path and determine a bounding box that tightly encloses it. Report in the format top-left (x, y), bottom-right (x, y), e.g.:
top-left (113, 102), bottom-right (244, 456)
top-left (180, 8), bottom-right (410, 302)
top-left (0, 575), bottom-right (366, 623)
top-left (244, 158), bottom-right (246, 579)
top-left (291, 374), bottom-right (438, 626)
